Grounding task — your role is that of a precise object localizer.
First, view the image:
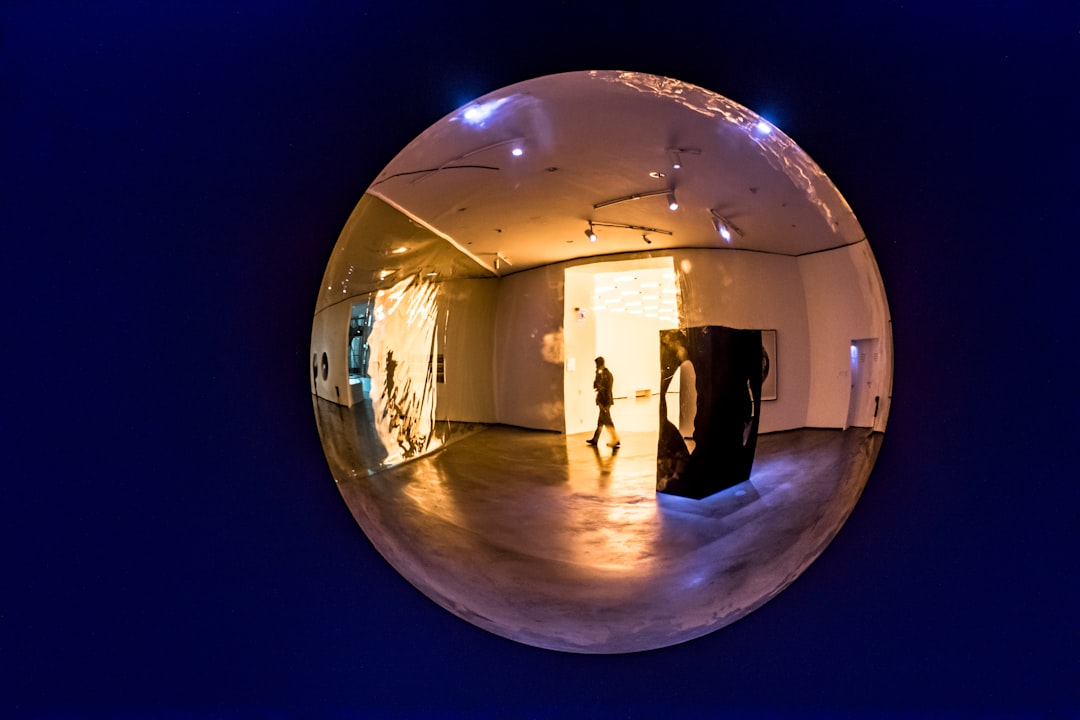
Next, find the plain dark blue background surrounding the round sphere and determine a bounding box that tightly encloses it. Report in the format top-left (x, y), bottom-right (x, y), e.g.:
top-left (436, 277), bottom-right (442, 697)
top-left (0, 0), bottom-right (1080, 718)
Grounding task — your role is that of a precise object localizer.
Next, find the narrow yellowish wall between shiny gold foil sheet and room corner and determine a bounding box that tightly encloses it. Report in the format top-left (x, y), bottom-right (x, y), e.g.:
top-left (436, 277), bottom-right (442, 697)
top-left (435, 279), bottom-right (500, 422)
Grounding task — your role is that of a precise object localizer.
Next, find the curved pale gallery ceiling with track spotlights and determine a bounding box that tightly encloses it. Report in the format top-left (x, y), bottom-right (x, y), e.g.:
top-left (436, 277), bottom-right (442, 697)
top-left (367, 71), bottom-right (863, 274)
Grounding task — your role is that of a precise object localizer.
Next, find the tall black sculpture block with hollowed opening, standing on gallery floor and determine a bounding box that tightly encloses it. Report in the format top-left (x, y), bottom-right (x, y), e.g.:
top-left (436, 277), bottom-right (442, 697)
top-left (657, 325), bottom-right (762, 500)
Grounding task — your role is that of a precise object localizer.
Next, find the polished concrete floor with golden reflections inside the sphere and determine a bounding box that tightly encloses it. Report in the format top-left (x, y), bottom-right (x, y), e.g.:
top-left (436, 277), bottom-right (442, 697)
top-left (315, 400), bottom-right (881, 653)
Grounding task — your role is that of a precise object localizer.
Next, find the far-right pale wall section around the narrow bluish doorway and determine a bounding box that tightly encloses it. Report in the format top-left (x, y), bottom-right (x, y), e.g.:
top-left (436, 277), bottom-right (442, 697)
top-left (799, 242), bottom-right (892, 430)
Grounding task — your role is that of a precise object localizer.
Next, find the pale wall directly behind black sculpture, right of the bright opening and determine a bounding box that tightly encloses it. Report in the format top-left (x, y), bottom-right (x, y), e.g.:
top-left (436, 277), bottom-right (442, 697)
top-left (672, 249), bottom-right (811, 433)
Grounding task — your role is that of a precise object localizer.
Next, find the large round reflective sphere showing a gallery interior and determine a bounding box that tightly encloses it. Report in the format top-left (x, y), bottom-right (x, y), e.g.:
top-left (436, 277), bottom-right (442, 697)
top-left (311, 71), bottom-right (893, 653)
